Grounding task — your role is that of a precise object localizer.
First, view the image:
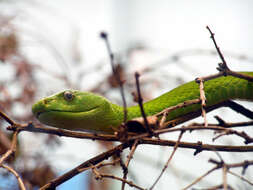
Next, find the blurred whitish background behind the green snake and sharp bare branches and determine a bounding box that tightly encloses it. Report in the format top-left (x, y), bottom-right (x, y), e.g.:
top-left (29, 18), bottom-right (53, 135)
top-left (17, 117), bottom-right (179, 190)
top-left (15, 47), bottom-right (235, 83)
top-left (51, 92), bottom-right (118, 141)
top-left (0, 0), bottom-right (253, 190)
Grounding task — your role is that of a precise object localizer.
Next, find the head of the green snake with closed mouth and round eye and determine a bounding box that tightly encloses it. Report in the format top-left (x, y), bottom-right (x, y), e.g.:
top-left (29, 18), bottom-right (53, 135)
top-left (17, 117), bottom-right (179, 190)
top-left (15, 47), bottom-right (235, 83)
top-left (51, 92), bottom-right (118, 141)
top-left (32, 90), bottom-right (120, 133)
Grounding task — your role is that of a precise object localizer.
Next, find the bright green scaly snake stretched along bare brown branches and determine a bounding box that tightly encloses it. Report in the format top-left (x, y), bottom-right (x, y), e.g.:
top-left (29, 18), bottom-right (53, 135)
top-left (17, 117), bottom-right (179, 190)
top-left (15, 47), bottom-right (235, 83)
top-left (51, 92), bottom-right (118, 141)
top-left (32, 72), bottom-right (253, 133)
